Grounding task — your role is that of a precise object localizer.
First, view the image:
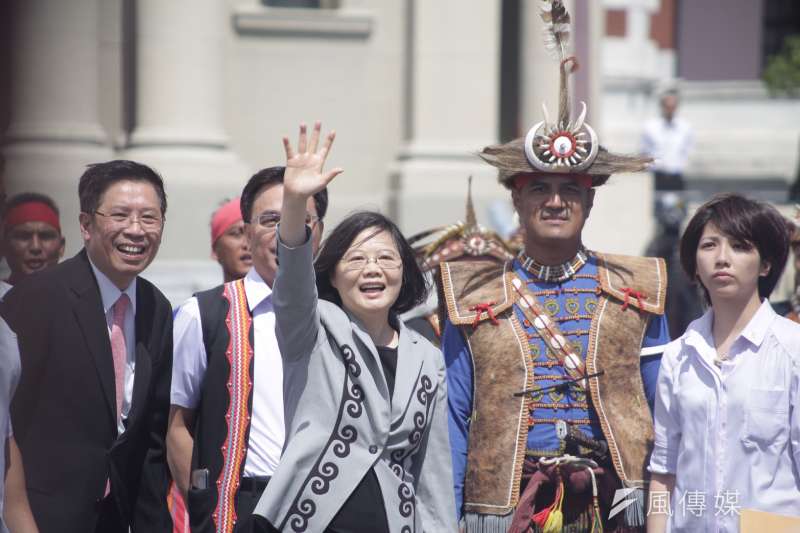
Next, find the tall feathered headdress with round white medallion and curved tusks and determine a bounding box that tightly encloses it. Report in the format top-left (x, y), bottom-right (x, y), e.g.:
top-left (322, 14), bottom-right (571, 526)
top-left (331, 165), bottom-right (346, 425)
top-left (479, 0), bottom-right (652, 187)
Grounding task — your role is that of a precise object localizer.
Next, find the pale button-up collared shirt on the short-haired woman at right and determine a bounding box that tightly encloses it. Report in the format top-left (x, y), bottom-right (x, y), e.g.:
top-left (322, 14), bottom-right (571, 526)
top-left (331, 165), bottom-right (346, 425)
top-left (650, 301), bottom-right (800, 532)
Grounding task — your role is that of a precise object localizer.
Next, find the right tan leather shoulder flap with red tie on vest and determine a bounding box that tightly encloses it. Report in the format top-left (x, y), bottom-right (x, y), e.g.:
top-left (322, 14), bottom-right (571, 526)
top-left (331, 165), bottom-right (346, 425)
top-left (592, 252), bottom-right (667, 315)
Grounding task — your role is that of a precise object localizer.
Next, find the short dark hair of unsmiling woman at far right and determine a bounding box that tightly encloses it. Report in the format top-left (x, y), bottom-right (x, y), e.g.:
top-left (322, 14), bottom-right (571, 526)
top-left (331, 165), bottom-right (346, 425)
top-left (680, 193), bottom-right (790, 304)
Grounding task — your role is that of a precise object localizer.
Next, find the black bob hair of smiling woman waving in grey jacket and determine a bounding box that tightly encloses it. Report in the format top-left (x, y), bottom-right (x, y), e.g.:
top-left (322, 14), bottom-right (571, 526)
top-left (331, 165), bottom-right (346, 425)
top-left (314, 211), bottom-right (428, 314)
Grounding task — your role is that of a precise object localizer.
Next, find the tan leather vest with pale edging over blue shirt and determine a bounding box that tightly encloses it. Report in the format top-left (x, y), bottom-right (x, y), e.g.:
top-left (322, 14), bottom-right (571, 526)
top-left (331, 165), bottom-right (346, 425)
top-left (441, 253), bottom-right (667, 515)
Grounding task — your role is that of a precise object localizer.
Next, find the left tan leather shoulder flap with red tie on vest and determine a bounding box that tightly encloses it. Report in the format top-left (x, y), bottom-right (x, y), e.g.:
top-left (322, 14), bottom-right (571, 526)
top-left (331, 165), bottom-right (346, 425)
top-left (440, 259), bottom-right (515, 325)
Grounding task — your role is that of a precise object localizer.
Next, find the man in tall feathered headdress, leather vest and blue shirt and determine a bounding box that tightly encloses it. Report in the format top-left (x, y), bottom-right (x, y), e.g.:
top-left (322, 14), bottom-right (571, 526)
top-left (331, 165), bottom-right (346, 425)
top-left (441, 0), bottom-right (669, 532)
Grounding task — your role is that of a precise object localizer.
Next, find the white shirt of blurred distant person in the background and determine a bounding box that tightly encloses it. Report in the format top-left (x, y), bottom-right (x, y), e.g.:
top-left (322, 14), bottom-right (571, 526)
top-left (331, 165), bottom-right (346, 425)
top-left (642, 117), bottom-right (693, 174)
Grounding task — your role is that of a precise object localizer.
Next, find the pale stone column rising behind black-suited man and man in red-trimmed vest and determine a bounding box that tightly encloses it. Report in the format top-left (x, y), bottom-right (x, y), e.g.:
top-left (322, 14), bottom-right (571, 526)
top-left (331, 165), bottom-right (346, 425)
top-left (124, 0), bottom-right (250, 296)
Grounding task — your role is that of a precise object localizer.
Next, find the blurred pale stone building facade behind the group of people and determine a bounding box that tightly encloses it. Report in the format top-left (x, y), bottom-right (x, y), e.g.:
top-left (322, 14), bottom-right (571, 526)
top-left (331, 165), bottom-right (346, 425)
top-left (0, 0), bottom-right (800, 303)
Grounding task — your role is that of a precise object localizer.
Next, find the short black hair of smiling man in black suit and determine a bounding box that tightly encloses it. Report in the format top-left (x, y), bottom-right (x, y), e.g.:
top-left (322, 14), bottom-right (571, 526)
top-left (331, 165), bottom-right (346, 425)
top-left (78, 159), bottom-right (167, 215)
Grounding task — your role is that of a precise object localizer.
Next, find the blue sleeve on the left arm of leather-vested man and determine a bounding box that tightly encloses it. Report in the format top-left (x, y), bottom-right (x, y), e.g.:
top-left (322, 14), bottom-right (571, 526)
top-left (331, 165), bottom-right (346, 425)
top-left (442, 320), bottom-right (472, 519)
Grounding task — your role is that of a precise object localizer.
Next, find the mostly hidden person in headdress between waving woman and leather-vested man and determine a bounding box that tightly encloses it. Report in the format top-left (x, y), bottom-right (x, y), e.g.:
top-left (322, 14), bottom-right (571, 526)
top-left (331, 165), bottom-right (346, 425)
top-left (403, 177), bottom-right (514, 345)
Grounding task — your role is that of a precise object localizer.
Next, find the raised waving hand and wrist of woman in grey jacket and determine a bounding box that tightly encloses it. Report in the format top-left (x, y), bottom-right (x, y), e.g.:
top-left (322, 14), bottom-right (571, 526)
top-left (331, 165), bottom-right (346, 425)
top-left (279, 122), bottom-right (342, 246)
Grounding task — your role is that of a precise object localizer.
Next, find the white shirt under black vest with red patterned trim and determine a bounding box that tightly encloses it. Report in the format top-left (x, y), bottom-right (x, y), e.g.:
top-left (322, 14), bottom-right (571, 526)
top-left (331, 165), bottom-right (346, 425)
top-left (170, 268), bottom-right (286, 477)
